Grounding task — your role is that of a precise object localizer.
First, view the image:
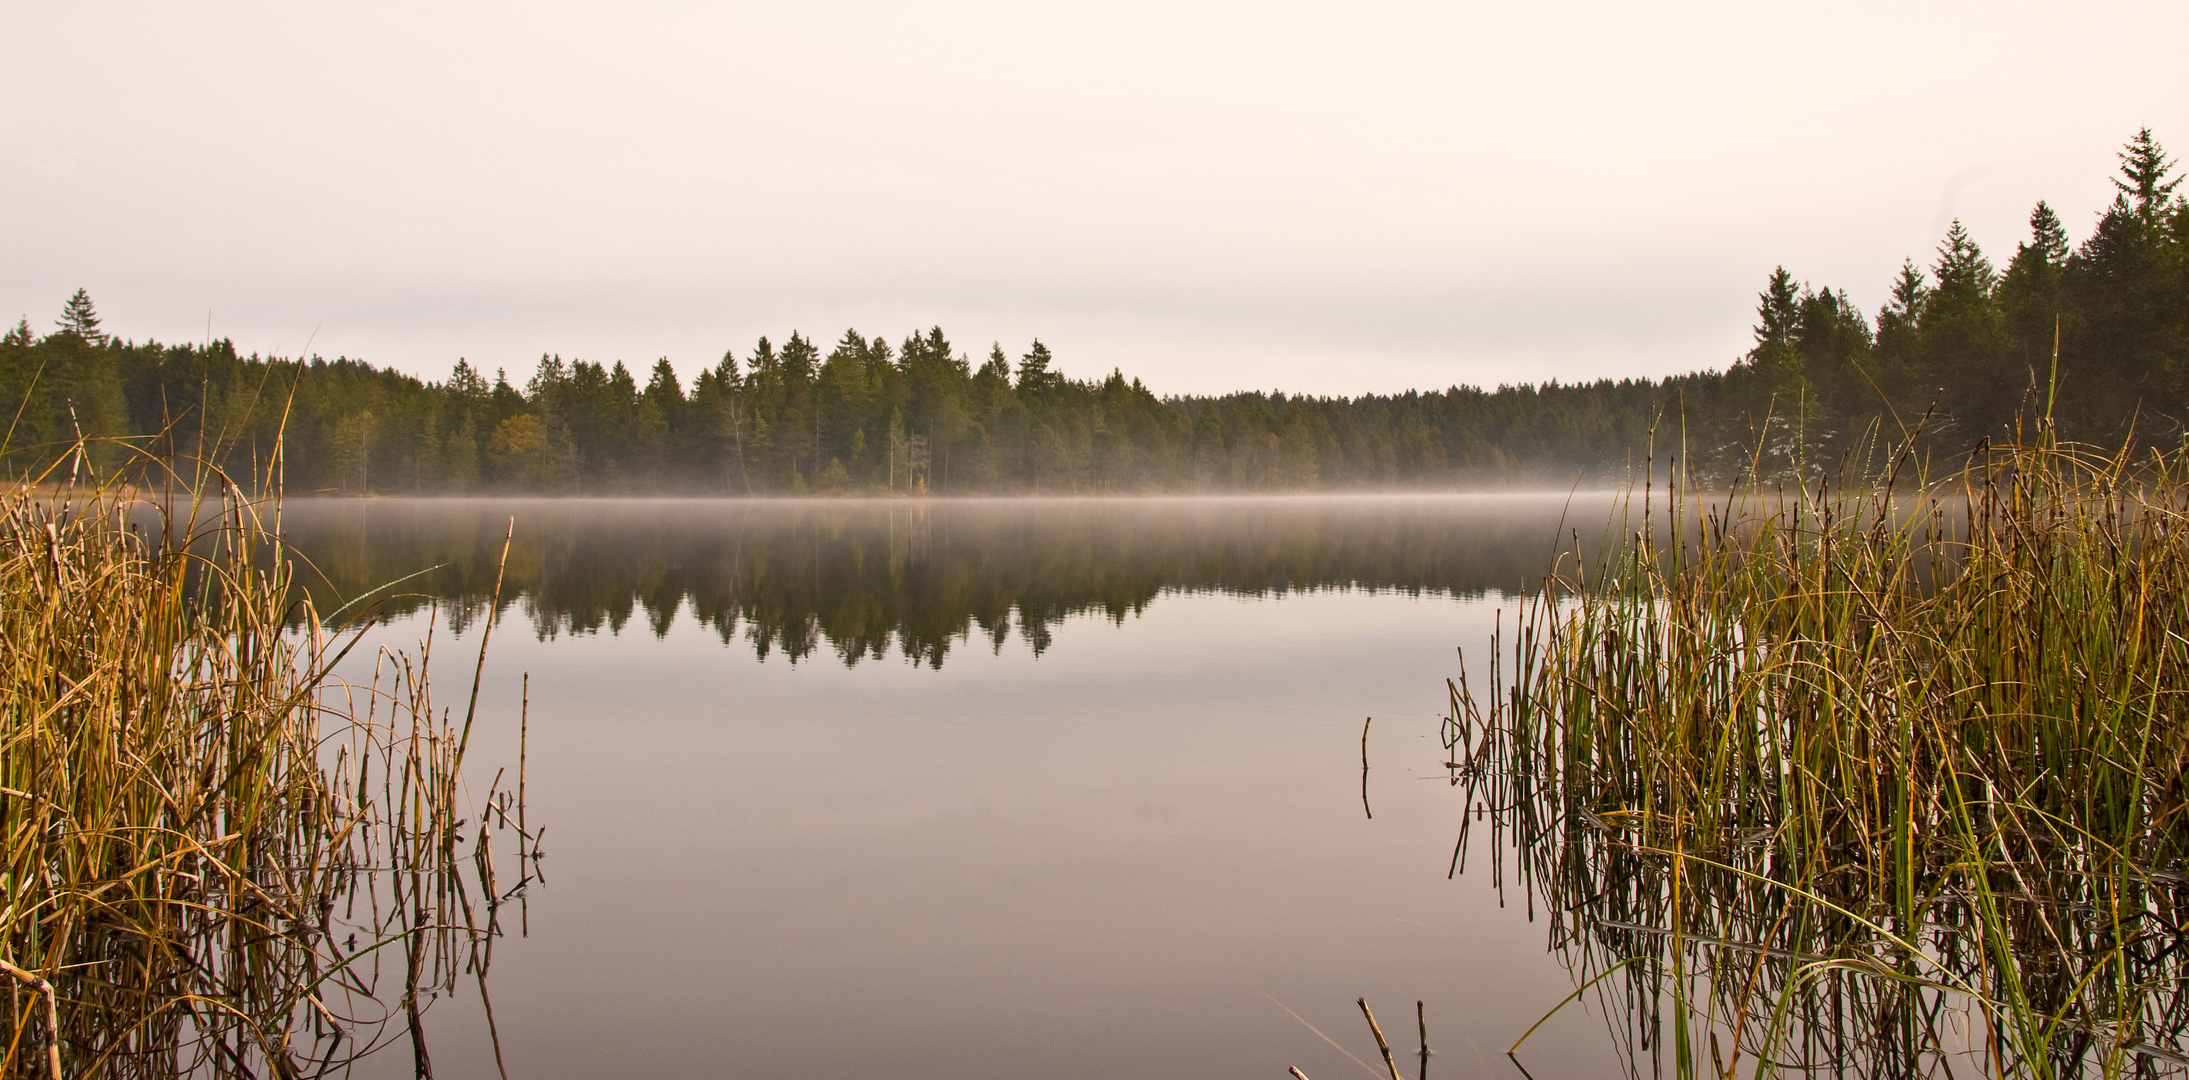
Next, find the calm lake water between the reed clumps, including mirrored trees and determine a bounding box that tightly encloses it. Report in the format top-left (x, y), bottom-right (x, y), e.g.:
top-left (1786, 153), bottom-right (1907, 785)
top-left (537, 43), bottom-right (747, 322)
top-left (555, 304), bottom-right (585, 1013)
top-left (299, 495), bottom-right (1624, 1080)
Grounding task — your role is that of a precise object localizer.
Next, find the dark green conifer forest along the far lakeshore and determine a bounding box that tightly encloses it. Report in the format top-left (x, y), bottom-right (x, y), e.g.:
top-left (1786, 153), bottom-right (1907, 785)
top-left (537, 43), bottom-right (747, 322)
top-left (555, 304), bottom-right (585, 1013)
top-left (0, 131), bottom-right (2189, 495)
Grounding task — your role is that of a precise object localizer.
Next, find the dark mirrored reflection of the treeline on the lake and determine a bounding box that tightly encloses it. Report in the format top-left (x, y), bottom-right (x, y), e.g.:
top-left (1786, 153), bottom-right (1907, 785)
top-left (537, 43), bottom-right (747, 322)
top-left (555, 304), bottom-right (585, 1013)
top-left (285, 495), bottom-right (1607, 668)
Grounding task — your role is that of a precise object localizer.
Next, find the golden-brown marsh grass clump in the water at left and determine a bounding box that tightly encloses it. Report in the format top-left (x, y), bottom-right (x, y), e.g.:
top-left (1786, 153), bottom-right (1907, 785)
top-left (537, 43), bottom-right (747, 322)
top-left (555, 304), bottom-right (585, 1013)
top-left (0, 442), bottom-right (534, 1078)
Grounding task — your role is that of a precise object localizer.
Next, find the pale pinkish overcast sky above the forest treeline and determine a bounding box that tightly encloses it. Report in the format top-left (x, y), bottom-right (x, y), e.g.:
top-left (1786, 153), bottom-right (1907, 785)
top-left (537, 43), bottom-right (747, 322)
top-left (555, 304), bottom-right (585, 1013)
top-left (0, 0), bottom-right (2189, 394)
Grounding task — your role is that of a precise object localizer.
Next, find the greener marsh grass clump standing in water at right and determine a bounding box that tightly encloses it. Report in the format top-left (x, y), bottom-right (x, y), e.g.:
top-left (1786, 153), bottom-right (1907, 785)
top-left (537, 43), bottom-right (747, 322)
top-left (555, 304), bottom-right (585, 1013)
top-left (1447, 431), bottom-right (2189, 1078)
